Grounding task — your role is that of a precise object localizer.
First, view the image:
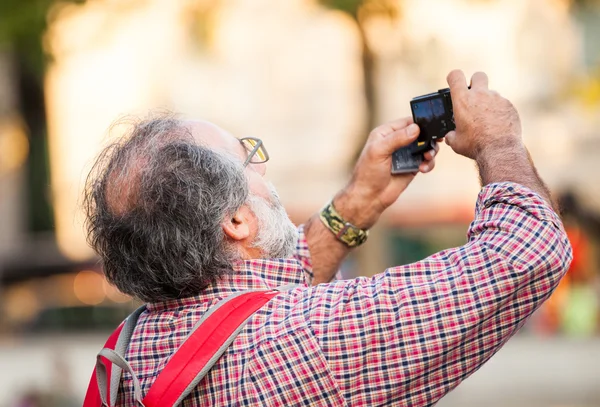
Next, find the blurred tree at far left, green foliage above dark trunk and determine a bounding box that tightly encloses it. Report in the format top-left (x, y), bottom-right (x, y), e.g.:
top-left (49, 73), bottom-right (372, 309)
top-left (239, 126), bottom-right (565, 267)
top-left (0, 0), bottom-right (85, 232)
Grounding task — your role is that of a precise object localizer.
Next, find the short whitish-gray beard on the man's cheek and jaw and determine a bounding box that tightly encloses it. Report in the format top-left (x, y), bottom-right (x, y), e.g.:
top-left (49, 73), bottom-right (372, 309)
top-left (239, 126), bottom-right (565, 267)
top-left (248, 183), bottom-right (298, 259)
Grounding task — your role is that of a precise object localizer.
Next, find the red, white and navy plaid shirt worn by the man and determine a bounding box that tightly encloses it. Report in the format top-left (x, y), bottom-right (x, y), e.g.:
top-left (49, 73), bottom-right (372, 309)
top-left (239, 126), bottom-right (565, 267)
top-left (117, 183), bottom-right (571, 407)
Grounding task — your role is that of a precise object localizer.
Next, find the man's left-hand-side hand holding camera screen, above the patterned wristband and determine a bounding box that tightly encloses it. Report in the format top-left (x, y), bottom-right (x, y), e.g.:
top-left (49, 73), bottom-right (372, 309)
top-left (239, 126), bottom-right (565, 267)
top-left (333, 117), bottom-right (439, 229)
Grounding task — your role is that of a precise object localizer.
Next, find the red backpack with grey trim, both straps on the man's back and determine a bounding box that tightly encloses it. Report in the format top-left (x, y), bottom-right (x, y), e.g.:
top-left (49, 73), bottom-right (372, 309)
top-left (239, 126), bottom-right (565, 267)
top-left (83, 286), bottom-right (284, 407)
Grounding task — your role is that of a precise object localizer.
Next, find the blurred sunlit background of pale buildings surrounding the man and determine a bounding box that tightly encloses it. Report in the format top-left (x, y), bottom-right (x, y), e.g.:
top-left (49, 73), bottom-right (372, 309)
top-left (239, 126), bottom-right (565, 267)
top-left (0, 0), bottom-right (600, 407)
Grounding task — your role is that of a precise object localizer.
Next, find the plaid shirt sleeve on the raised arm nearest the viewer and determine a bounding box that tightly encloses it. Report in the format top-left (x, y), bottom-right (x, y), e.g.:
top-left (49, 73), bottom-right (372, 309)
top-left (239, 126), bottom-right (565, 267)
top-left (303, 183), bottom-right (572, 405)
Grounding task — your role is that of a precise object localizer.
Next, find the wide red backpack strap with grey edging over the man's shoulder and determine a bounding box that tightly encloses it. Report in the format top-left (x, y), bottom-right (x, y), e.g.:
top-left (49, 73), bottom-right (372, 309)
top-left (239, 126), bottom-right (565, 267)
top-left (143, 291), bottom-right (280, 407)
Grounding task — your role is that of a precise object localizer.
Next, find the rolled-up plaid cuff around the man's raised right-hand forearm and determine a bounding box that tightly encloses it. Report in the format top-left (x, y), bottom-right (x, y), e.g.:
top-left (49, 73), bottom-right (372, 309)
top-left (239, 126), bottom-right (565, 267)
top-left (475, 182), bottom-right (562, 229)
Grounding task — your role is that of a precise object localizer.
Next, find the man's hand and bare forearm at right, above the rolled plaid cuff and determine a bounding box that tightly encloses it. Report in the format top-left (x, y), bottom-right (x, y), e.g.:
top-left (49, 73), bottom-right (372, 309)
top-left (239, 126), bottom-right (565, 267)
top-left (446, 71), bottom-right (556, 209)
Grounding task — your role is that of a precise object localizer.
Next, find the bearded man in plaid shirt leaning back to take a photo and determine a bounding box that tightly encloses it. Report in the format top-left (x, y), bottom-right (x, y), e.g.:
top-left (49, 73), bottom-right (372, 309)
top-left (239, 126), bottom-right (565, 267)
top-left (87, 71), bottom-right (571, 406)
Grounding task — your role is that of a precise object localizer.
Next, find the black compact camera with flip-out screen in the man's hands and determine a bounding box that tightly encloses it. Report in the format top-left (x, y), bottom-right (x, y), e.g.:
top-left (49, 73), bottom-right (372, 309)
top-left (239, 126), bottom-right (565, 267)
top-left (392, 88), bottom-right (456, 174)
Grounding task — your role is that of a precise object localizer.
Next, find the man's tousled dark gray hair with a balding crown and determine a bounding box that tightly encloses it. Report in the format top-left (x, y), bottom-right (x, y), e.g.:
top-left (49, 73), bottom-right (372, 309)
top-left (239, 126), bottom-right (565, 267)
top-left (84, 116), bottom-right (248, 302)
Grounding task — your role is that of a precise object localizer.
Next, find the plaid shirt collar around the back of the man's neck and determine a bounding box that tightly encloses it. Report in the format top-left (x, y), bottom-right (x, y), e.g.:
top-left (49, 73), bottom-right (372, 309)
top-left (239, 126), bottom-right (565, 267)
top-left (146, 258), bottom-right (306, 312)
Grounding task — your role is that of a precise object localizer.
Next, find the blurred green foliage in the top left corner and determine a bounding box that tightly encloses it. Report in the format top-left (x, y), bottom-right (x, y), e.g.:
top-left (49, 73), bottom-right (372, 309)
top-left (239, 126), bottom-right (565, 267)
top-left (0, 0), bottom-right (85, 77)
